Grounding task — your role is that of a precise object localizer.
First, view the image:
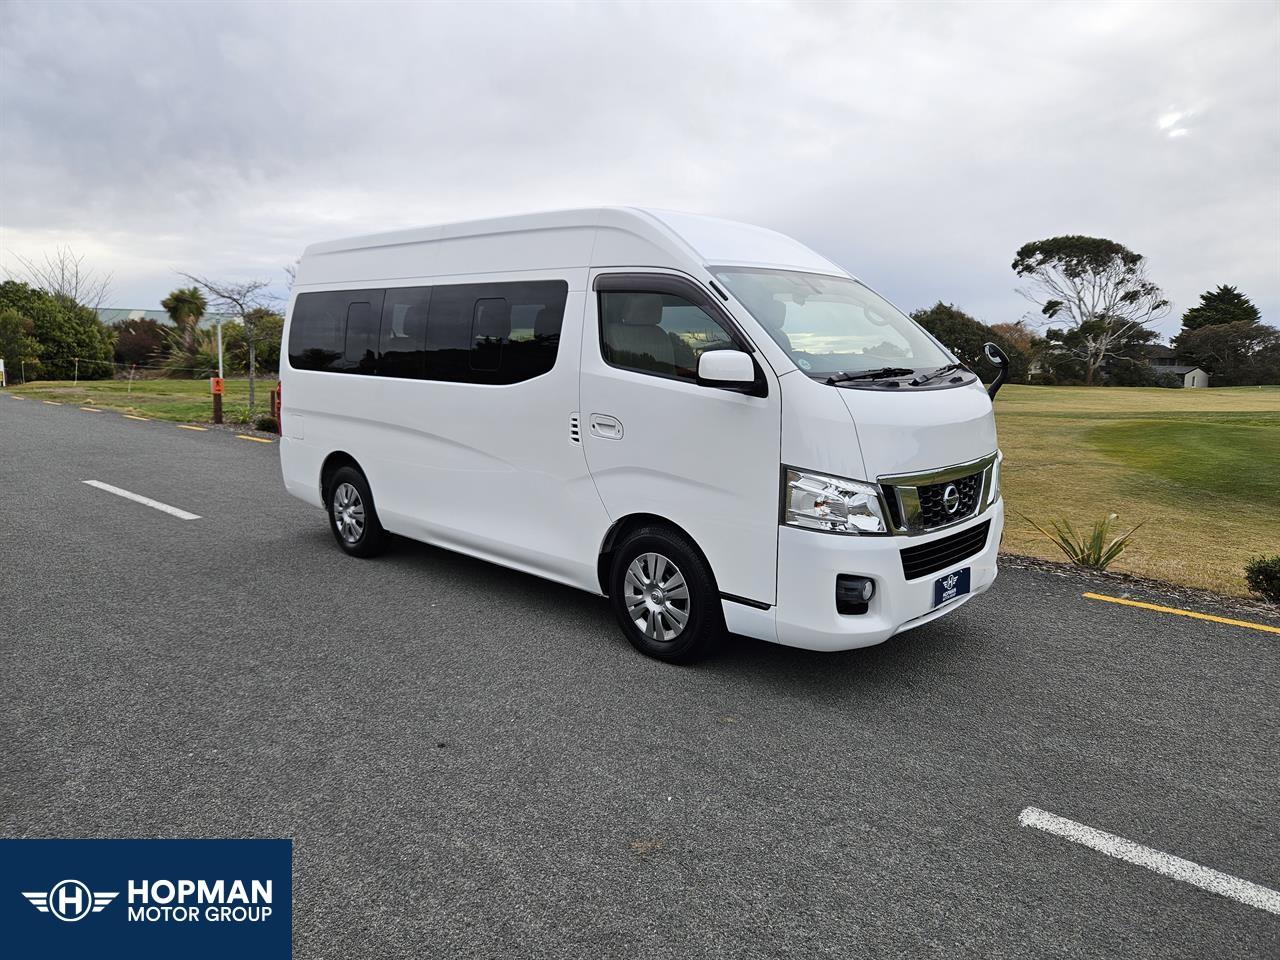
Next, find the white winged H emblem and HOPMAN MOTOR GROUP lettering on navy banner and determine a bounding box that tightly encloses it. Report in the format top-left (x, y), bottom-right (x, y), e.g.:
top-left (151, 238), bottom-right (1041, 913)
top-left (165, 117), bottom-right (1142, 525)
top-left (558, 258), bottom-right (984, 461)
top-left (22, 879), bottom-right (271, 923)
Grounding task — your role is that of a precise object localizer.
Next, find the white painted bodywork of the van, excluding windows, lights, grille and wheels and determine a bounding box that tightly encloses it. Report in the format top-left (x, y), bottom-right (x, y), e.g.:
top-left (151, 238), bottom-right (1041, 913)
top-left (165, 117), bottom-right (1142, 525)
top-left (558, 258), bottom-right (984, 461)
top-left (280, 207), bottom-right (1004, 650)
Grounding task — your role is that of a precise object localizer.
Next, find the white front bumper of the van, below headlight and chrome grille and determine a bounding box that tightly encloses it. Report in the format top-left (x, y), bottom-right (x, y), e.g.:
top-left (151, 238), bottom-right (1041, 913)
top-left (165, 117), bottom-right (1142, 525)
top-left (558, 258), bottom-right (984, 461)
top-left (774, 499), bottom-right (1005, 650)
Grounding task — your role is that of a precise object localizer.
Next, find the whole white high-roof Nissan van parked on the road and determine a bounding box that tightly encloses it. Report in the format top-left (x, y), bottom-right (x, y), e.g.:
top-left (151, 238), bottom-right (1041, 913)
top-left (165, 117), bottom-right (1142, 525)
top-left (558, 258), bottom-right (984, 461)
top-left (280, 209), bottom-right (1004, 662)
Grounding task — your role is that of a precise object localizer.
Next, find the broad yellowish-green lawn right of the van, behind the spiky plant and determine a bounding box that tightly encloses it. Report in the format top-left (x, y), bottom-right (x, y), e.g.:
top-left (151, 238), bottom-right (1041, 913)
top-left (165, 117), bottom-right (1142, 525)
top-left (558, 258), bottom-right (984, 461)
top-left (996, 385), bottom-right (1280, 595)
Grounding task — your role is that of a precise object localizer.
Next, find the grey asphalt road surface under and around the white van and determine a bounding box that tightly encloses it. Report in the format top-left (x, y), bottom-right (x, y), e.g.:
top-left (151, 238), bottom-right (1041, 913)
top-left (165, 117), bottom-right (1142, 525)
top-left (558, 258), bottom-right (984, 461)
top-left (0, 397), bottom-right (1280, 957)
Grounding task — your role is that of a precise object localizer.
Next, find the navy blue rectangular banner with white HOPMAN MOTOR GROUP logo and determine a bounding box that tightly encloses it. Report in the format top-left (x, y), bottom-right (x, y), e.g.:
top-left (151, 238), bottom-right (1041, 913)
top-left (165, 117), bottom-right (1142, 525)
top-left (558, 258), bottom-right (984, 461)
top-left (0, 840), bottom-right (293, 960)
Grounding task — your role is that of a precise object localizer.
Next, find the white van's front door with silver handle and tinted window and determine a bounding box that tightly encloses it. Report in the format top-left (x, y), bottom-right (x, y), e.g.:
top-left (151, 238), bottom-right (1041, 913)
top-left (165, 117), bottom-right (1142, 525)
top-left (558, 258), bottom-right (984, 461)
top-left (580, 270), bottom-right (781, 604)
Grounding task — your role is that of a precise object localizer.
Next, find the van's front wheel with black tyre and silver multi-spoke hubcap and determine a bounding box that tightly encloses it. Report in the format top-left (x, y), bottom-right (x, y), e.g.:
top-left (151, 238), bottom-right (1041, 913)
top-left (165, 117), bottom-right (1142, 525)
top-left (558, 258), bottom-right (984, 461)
top-left (609, 526), bottom-right (724, 663)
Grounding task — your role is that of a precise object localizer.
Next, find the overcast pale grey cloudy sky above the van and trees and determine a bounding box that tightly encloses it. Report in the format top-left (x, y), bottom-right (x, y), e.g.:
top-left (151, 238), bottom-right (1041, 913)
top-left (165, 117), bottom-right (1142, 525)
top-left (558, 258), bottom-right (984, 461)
top-left (0, 0), bottom-right (1280, 330)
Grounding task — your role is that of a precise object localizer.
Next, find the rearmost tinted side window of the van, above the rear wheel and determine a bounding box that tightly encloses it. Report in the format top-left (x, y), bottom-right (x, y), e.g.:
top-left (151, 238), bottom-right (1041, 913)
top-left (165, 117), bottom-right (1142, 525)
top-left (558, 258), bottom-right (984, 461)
top-left (289, 291), bottom-right (383, 372)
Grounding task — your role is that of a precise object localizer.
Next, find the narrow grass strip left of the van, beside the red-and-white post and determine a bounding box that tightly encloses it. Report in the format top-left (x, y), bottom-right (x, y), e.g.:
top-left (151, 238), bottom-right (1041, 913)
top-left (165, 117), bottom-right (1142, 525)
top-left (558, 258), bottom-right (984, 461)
top-left (12, 375), bottom-right (276, 424)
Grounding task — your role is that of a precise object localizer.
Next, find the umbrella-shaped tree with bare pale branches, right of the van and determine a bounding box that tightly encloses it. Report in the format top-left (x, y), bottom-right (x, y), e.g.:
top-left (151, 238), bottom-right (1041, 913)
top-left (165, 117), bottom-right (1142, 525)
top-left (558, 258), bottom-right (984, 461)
top-left (1012, 236), bottom-right (1169, 384)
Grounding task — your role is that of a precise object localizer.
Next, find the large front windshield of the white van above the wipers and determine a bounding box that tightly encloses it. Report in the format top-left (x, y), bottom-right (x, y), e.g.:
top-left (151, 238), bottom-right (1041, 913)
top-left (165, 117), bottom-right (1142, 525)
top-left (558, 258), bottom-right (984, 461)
top-left (712, 268), bottom-right (955, 378)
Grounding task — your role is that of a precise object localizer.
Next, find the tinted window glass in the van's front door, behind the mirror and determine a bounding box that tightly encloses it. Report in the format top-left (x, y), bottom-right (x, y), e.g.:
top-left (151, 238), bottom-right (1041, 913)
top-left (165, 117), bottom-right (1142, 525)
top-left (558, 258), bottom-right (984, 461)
top-left (600, 291), bottom-right (736, 380)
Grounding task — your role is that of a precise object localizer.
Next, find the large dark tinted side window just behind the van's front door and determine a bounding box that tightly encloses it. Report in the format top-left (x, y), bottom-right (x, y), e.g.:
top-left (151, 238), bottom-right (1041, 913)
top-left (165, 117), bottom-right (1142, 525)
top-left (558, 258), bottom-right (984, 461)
top-left (426, 280), bottom-right (568, 384)
